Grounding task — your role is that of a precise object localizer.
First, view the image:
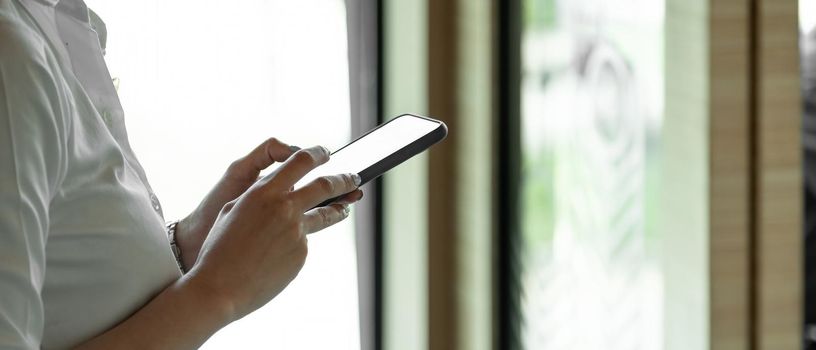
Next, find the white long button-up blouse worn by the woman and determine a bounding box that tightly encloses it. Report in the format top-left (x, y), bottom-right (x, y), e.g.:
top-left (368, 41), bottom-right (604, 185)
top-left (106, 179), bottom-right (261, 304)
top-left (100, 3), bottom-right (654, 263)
top-left (0, 0), bottom-right (180, 349)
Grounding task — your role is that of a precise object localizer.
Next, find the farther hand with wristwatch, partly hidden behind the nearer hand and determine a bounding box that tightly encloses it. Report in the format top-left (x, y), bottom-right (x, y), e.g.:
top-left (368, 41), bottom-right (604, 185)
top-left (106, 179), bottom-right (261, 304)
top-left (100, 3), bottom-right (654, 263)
top-left (176, 138), bottom-right (362, 270)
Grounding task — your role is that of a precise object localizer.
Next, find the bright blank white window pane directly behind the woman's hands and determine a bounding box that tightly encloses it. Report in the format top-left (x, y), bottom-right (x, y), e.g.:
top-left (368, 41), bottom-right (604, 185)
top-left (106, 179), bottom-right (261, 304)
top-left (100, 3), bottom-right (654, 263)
top-left (87, 0), bottom-right (360, 349)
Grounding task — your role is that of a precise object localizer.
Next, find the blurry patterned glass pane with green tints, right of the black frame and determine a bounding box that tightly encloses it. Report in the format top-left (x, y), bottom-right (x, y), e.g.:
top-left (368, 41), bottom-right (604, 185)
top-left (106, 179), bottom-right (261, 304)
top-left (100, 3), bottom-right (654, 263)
top-left (521, 0), bottom-right (664, 350)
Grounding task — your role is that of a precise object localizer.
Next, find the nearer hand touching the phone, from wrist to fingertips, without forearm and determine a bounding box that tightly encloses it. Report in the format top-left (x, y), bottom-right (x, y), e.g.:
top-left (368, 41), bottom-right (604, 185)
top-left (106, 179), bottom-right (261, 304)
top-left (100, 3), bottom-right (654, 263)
top-left (185, 147), bottom-right (362, 319)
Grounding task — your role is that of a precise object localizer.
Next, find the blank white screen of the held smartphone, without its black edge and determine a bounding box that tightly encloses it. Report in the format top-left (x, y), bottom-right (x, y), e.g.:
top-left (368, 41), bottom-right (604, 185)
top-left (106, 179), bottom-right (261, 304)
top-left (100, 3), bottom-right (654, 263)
top-left (295, 115), bottom-right (439, 189)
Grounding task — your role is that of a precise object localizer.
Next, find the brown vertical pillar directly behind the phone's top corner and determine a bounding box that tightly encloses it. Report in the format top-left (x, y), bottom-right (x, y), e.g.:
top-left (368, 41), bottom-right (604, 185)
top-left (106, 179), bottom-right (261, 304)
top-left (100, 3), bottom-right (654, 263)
top-left (428, 0), bottom-right (460, 350)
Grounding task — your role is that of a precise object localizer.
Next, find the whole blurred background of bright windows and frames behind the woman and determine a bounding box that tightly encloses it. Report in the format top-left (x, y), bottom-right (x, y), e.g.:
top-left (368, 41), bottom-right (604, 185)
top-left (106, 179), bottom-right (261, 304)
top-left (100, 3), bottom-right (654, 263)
top-left (86, 0), bottom-right (816, 350)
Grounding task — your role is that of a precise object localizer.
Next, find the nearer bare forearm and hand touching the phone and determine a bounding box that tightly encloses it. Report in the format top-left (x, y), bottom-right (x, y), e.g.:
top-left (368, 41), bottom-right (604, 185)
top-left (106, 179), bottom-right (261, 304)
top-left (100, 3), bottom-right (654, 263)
top-left (78, 140), bottom-right (362, 350)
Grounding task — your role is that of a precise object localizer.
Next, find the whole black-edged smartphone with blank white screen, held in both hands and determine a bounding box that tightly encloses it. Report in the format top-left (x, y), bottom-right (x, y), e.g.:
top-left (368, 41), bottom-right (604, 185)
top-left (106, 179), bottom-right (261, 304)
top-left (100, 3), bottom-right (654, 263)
top-left (295, 114), bottom-right (448, 207)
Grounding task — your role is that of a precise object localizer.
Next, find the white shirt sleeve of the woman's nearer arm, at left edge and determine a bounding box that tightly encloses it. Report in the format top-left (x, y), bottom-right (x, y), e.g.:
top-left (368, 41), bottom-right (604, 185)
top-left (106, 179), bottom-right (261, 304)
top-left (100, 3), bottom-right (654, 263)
top-left (0, 19), bottom-right (66, 349)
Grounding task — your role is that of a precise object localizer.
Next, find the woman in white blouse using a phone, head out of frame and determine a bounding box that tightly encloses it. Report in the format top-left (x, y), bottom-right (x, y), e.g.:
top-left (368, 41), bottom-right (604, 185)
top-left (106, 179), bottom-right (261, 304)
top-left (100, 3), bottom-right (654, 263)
top-left (0, 0), bottom-right (362, 349)
